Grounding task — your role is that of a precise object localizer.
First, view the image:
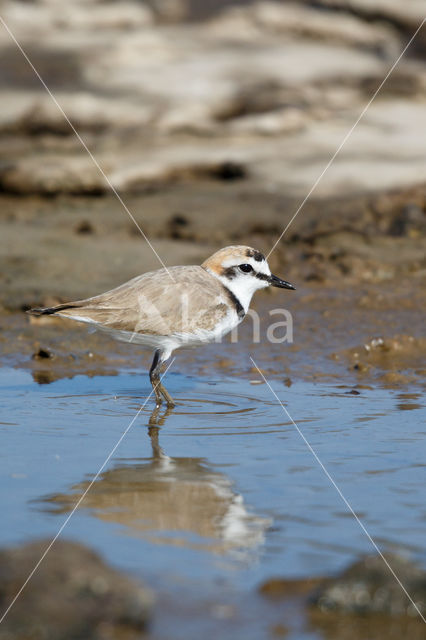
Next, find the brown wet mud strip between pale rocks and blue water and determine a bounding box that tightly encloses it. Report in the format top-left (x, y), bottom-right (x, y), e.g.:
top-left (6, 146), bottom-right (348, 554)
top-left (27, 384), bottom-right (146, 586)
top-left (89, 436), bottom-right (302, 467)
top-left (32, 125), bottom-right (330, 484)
top-left (1, 183), bottom-right (426, 385)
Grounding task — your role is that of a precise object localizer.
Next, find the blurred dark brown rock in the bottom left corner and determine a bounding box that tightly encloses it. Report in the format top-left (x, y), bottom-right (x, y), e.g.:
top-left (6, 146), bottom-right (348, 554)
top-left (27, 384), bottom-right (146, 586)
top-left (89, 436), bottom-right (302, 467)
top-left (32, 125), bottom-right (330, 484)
top-left (0, 540), bottom-right (153, 640)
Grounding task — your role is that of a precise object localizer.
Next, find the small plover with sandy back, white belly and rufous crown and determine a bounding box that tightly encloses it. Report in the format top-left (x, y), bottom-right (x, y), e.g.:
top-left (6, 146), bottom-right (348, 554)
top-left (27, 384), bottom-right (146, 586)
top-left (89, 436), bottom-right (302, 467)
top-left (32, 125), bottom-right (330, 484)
top-left (28, 245), bottom-right (295, 408)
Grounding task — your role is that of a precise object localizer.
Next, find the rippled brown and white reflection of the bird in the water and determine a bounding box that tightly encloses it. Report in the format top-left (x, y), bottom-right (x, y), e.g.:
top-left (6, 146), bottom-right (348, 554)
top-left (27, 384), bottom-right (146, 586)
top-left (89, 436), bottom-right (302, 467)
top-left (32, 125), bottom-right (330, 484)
top-left (47, 410), bottom-right (271, 559)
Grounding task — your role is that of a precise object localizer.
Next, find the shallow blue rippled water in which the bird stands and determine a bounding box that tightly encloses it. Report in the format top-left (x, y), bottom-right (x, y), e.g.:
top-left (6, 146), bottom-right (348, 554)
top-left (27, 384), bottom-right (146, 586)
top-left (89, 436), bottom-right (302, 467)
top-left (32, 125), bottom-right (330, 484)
top-left (0, 369), bottom-right (426, 638)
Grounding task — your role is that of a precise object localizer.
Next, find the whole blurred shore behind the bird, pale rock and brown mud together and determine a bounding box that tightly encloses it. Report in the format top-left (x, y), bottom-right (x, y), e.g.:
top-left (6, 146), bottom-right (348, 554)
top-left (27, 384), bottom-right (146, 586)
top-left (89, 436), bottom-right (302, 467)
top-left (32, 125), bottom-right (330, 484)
top-left (0, 0), bottom-right (426, 384)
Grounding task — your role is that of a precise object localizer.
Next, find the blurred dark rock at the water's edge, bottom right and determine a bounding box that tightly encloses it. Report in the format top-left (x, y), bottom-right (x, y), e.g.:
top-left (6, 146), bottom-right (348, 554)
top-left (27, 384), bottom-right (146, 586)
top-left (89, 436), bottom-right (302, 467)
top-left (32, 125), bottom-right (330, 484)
top-left (311, 553), bottom-right (426, 622)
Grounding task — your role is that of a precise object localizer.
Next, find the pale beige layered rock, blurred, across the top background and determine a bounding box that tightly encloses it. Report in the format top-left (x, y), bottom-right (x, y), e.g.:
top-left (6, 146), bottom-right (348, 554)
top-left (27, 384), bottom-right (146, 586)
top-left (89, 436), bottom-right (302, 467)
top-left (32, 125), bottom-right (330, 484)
top-left (0, 0), bottom-right (426, 200)
